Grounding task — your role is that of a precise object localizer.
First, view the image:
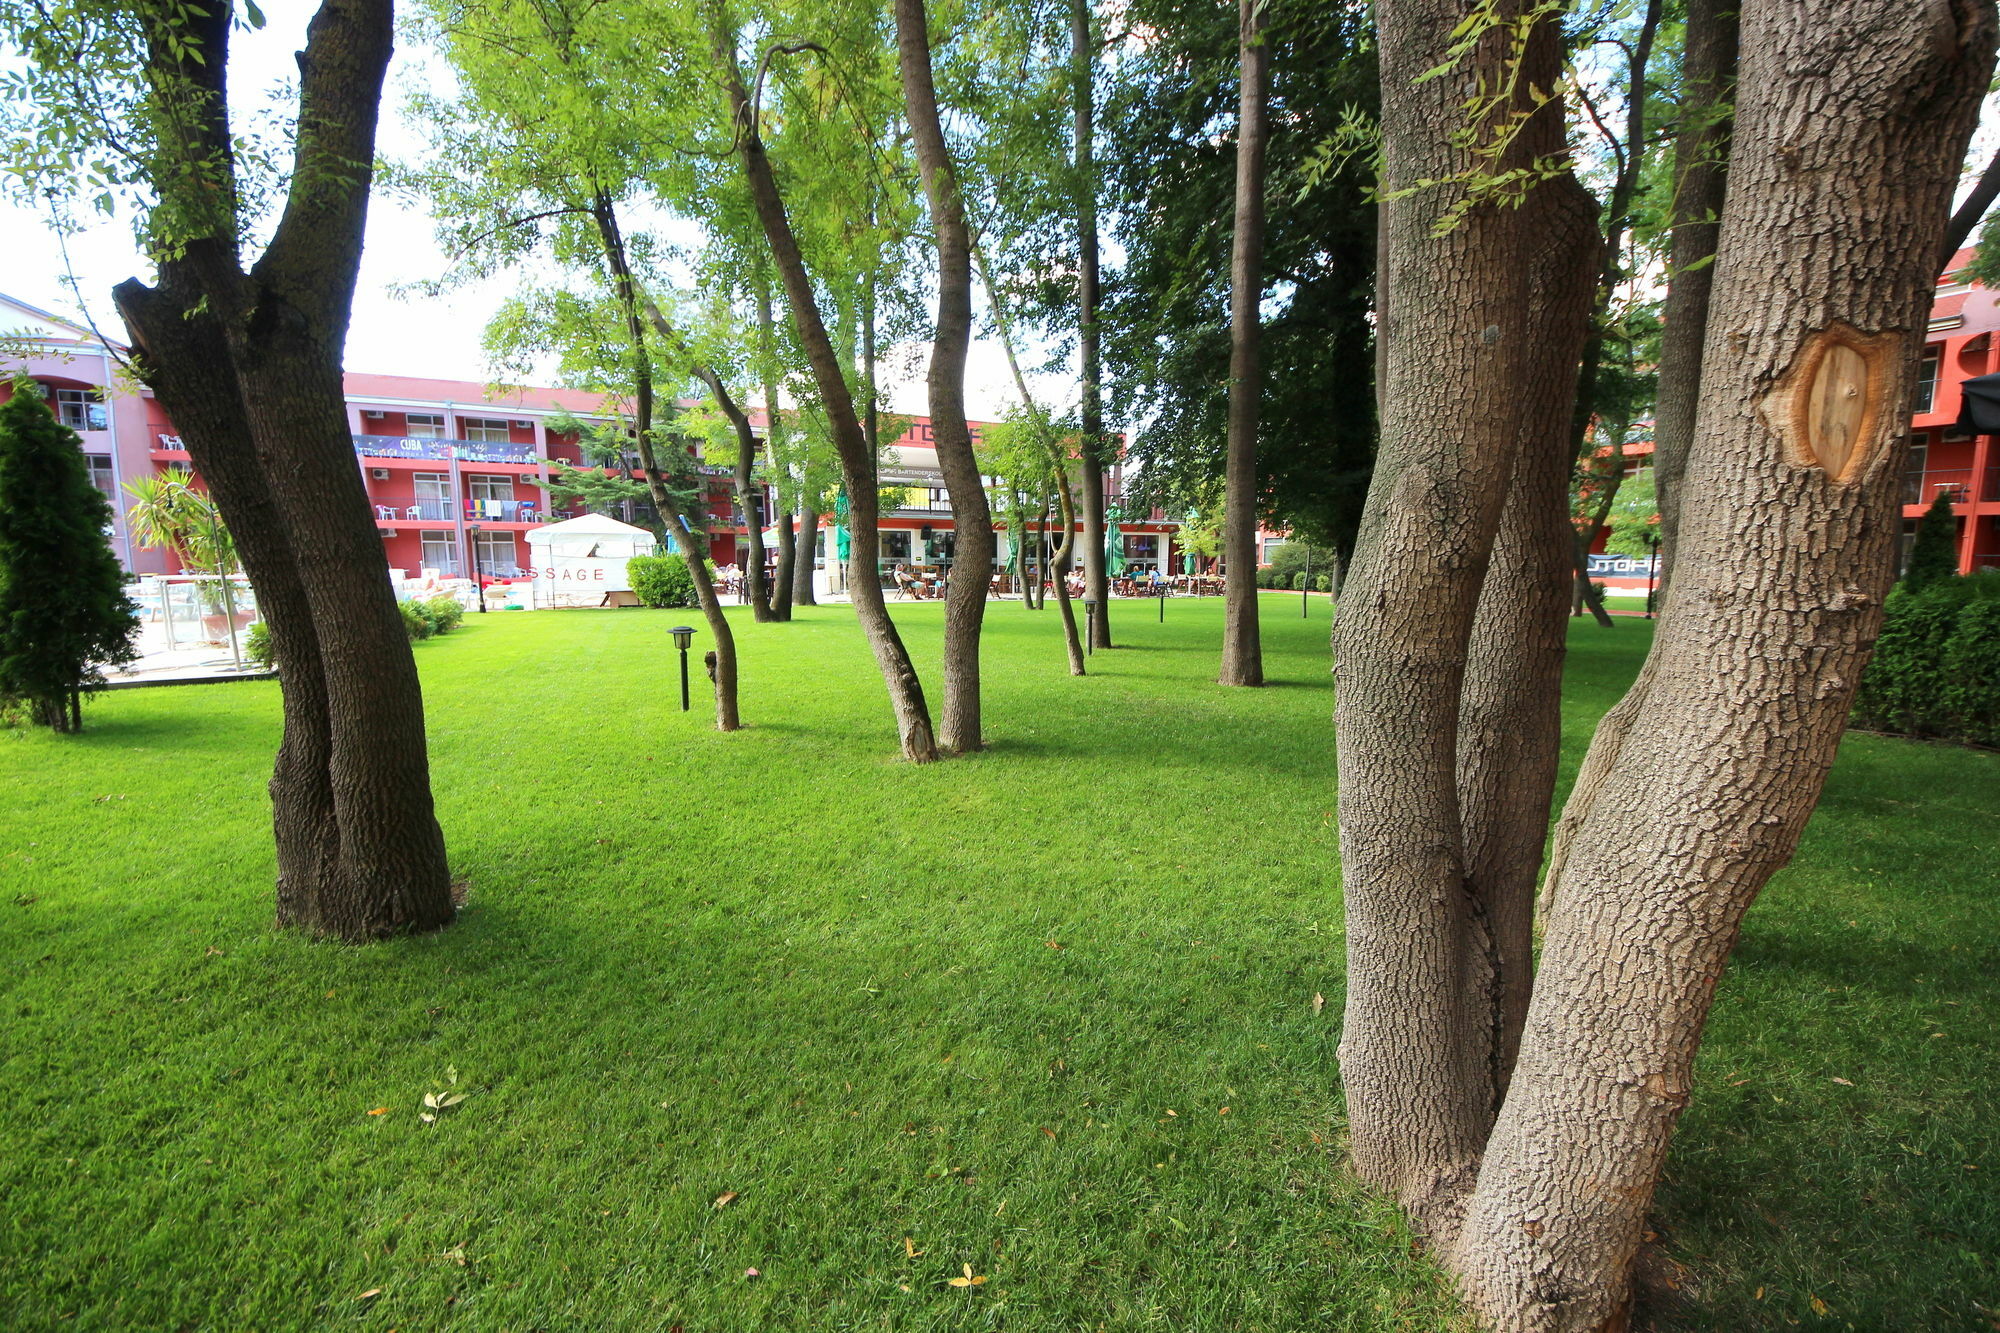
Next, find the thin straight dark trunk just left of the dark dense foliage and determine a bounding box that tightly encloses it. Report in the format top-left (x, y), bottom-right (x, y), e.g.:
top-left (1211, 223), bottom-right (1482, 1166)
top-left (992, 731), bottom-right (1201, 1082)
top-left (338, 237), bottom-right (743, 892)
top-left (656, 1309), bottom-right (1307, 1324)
top-left (1070, 0), bottom-right (1112, 648)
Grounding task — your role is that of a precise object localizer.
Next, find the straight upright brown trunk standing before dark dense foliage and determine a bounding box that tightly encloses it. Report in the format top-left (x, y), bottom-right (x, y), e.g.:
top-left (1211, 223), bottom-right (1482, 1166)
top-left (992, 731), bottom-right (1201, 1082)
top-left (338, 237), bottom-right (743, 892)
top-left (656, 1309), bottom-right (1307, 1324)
top-left (1218, 0), bottom-right (1270, 685)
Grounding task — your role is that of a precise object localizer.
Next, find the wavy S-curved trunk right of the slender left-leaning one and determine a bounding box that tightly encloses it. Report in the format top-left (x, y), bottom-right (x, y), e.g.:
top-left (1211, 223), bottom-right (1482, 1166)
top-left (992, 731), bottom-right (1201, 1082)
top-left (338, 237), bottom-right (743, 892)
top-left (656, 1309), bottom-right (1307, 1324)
top-left (896, 0), bottom-right (994, 755)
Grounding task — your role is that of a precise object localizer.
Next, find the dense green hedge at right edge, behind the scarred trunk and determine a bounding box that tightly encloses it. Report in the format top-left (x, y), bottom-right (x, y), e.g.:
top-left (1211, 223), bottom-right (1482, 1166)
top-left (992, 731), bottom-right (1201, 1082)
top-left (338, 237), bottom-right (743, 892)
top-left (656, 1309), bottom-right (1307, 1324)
top-left (1854, 570), bottom-right (2000, 745)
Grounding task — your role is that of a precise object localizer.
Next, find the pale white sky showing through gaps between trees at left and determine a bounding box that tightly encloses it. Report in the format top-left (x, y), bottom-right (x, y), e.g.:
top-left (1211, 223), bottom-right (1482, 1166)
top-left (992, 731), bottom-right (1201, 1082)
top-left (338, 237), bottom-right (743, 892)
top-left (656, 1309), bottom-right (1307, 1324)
top-left (0, 0), bottom-right (1076, 420)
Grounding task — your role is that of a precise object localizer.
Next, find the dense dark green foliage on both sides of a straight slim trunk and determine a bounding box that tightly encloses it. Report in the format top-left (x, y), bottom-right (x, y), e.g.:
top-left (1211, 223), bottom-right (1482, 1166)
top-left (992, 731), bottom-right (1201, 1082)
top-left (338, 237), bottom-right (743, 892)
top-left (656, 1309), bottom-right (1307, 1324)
top-left (1104, 0), bottom-right (1378, 548)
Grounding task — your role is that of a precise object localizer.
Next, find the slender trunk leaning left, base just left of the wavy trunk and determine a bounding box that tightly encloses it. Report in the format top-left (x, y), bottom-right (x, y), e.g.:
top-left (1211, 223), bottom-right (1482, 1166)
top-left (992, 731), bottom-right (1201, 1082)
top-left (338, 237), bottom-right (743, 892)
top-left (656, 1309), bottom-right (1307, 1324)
top-left (716, 30), bottom-right (938, 763)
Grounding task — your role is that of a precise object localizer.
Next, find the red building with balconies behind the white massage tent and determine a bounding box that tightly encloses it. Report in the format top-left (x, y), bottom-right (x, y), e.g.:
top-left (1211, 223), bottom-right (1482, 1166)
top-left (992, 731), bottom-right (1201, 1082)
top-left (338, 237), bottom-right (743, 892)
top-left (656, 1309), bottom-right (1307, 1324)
top-left (0, 296), bottom-right (1178, 588)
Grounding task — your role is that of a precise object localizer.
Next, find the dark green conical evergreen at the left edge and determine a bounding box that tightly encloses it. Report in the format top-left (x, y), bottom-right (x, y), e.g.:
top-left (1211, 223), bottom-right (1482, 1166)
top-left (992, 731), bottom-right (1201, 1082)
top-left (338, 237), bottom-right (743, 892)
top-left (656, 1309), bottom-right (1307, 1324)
top-left (0, 380), bottom-right (138, 731)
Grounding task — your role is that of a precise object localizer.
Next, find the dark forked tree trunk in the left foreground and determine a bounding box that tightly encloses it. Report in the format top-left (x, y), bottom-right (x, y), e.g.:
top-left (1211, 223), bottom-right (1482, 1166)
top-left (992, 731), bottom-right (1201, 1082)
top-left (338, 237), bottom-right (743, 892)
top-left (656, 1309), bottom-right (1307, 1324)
top-left (118, 0), bottom-right (452, 941)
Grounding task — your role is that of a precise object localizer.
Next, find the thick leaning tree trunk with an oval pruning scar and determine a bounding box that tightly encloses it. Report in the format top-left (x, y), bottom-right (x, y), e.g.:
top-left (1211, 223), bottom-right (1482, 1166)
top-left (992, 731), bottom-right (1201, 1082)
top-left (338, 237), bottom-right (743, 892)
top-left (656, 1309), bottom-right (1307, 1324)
top-left (1454, 0), bottom-right (1994, 1333)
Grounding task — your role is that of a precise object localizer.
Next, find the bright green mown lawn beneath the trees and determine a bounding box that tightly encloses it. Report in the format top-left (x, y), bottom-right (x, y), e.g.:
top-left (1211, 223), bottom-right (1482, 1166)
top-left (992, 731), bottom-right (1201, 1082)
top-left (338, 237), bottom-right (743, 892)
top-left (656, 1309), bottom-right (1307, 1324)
top-left (0, 594), bottom-right (2000, 1333)
